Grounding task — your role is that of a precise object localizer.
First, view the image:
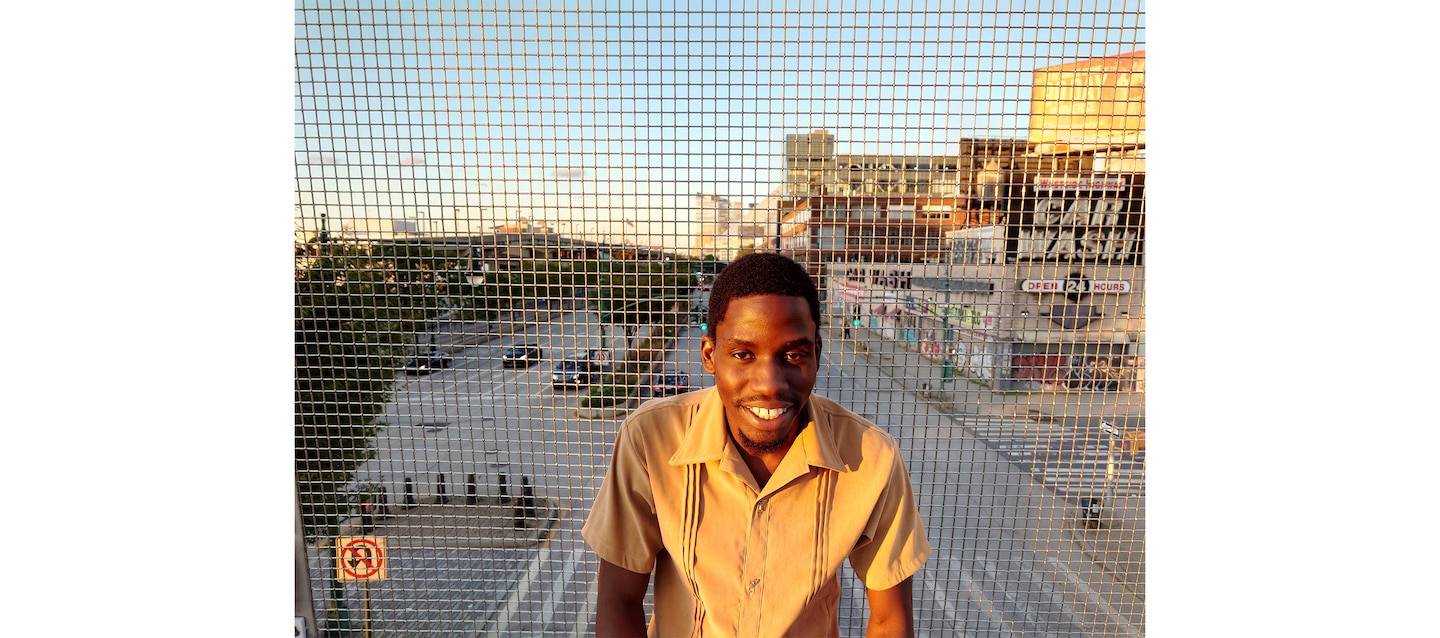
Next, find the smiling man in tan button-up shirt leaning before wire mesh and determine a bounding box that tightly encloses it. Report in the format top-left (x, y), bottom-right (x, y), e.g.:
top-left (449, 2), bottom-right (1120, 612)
top-left (583, 253), bottom-right (930, 638)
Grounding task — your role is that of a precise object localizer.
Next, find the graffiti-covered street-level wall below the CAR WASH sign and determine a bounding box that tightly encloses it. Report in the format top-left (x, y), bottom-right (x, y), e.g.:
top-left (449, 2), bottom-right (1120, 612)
top-left (827, 259), bottom-right (1145, 390)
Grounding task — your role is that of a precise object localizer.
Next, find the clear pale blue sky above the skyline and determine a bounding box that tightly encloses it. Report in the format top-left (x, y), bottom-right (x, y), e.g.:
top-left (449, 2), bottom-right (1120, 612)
top-left (295, 0), bottom-right (1145, 240)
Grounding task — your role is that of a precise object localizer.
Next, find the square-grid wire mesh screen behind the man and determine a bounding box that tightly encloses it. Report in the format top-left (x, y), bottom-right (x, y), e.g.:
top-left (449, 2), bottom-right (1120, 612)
top-left (295, 0), bottom-right (1145, 637)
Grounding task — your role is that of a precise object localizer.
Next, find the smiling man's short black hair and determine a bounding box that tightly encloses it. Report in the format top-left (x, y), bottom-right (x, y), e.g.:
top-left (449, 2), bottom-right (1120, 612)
top-left (706, 252), bottom-right (819, 349)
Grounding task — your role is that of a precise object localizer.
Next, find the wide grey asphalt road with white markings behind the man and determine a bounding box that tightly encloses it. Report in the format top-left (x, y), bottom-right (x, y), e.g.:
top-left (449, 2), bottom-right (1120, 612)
top-left (317, 305), bottom-right (1143, 637)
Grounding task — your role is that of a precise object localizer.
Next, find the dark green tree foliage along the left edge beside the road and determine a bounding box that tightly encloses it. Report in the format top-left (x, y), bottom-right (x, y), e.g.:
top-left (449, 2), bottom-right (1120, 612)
top-left (295, 243), bottom-right (471, 537)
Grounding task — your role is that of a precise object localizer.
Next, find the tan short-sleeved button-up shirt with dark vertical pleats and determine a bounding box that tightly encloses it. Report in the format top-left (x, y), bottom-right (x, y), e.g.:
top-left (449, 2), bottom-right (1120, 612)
top-left (583, 387), bottom-right (930, 638)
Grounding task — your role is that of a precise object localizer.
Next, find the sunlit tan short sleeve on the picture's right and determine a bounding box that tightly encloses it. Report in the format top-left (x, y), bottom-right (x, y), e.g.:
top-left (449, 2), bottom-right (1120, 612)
top-left (850, 451), bottom-right (930, 589)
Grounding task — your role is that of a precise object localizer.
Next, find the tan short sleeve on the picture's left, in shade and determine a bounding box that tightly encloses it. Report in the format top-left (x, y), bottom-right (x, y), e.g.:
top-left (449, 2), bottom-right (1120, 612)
top-left (580, 422), bottom-right (662, 573)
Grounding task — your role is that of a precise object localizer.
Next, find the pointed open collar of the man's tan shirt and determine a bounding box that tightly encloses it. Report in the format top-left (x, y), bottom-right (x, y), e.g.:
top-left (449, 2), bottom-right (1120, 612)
top-left (670, 387), bottom-right (848, 472)
